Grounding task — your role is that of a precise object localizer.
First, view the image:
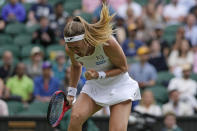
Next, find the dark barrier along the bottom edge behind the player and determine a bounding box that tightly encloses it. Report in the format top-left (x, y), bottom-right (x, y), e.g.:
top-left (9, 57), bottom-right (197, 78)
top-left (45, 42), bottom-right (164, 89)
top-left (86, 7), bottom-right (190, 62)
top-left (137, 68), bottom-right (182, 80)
top-left (0, 116), bottom-right (197, 131)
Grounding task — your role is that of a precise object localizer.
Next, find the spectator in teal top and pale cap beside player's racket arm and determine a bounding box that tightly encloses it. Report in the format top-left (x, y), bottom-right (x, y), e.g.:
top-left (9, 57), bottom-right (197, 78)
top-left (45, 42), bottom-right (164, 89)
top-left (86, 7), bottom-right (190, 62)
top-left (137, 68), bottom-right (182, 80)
top-left (52, 51), bottom-right (68, 81)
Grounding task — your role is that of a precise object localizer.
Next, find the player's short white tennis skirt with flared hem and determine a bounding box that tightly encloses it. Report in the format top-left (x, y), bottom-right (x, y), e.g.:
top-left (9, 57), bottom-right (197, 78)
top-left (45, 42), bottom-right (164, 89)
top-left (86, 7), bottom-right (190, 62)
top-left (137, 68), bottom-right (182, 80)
top-left (81, 72), bottom-right (141, 106)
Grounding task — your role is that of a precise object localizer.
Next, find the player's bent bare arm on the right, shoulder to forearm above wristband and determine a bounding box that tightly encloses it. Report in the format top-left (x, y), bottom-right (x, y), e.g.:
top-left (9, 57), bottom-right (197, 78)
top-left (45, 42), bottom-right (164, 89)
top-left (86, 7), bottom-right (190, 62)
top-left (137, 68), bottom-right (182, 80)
top-left (103, 36), bottom-right (128, 77)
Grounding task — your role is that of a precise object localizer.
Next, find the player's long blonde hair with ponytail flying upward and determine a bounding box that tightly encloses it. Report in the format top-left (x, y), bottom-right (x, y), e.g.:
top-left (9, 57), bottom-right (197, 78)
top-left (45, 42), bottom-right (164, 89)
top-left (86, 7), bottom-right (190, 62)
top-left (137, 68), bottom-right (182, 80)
top-left (64, 4), bottom-right (115, 46)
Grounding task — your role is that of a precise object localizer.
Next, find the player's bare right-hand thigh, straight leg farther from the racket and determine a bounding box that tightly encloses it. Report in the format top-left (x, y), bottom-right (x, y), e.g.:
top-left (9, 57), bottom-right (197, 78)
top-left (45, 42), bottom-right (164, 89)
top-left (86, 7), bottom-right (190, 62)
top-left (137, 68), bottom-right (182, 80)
top-left (109, 100), bottom-right (132, 131)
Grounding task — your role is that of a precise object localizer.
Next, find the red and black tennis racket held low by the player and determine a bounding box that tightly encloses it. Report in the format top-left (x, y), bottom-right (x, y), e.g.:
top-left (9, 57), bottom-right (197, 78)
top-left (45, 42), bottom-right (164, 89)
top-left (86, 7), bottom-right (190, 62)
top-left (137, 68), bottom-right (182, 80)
top-left (47, 90), bottom-right (71, 127)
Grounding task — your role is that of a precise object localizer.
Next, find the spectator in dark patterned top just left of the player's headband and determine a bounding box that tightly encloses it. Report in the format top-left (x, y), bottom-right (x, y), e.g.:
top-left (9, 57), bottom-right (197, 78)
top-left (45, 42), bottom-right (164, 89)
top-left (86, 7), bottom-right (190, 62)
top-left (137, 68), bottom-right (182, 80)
top-left (49, 2), bottom-right (68, 38)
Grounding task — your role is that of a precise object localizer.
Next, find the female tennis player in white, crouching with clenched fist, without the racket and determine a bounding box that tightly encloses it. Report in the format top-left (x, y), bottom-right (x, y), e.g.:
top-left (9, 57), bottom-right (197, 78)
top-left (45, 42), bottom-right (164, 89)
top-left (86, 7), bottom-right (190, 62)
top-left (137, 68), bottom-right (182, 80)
top-left (64, 4), bottom-right (141, 131)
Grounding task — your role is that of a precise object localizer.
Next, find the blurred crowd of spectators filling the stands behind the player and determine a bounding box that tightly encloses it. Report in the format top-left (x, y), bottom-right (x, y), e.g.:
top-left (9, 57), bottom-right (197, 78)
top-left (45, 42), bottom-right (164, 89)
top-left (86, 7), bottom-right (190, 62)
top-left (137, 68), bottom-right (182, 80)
top-left (0, 0), bottom-right (197, 126)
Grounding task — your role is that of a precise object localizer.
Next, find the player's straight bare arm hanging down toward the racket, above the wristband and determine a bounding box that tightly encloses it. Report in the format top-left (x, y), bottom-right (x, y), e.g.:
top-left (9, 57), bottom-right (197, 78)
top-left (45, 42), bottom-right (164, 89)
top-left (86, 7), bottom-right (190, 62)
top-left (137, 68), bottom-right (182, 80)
top-left (66, 46), bottom-right (82, 88)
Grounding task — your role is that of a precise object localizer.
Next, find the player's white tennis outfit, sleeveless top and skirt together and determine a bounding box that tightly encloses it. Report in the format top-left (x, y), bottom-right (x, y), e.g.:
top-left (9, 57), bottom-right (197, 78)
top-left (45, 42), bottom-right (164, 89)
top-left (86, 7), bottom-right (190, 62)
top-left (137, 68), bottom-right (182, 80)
top-left (75, 45), bottom-right (141, 106)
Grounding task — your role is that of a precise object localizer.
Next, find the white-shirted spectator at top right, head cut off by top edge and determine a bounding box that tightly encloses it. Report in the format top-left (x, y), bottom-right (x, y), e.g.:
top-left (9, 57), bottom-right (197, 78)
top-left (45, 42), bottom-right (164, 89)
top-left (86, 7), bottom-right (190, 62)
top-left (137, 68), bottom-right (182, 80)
top-left (163, 0), bottom-right (187, 24)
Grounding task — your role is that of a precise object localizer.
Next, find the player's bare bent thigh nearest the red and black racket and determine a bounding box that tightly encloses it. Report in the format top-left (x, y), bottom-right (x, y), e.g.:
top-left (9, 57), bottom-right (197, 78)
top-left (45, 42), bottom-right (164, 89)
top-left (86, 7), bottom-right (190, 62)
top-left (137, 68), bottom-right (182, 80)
top-left (71, 93), bottom-right (102, 122)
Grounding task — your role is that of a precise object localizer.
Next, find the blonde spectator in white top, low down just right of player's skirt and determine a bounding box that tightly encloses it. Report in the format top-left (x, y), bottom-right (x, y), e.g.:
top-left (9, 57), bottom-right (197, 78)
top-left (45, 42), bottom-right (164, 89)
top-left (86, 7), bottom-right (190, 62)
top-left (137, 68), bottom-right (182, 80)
top-left (134, 90), bottom-right (162, 116)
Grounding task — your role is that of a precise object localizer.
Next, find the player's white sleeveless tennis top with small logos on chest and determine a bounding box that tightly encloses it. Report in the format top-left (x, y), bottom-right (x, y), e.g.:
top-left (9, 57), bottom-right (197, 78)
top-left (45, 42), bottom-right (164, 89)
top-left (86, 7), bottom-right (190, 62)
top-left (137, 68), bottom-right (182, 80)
top-left (75, 44), bottom-right (113, 71)
